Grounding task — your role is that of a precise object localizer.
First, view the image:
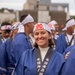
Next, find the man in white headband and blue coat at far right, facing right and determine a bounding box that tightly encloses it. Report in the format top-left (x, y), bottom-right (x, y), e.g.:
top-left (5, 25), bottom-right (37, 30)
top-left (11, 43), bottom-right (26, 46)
top-left (56, 19), bottom-right (75, 53)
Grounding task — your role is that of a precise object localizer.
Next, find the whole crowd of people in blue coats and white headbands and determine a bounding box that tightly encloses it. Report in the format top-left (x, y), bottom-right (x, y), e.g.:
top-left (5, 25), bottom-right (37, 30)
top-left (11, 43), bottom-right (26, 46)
top-left (0, 14), bottom-right (75, 75)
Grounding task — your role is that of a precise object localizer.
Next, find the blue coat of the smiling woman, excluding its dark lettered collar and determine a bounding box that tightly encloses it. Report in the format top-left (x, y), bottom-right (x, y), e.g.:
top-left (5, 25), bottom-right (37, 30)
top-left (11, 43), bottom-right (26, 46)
top-left (14, 50), bottom-right (64, 75)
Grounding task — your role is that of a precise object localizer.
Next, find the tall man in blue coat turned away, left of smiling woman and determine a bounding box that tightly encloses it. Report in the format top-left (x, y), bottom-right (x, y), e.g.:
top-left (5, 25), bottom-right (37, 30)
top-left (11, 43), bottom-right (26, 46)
top-left (13, 14), bottom-right (34, 63)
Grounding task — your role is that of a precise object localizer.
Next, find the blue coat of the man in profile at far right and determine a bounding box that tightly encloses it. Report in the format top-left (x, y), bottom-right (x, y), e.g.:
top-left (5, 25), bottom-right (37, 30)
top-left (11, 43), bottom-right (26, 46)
top-left (56, 34), bottom-right (67, 54)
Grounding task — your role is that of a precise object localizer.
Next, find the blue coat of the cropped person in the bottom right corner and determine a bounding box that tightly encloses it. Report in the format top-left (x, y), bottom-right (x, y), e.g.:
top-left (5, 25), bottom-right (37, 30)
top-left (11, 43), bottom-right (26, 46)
top-left (61, 45), bottom-right (75, 75)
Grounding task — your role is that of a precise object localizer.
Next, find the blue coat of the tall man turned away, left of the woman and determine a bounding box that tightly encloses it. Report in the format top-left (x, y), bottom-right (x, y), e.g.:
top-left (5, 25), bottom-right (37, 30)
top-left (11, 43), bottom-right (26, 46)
top-left (13, 33), bottom-right (32, 63)
